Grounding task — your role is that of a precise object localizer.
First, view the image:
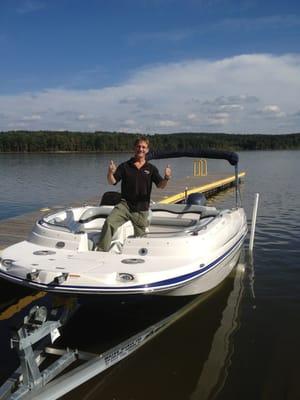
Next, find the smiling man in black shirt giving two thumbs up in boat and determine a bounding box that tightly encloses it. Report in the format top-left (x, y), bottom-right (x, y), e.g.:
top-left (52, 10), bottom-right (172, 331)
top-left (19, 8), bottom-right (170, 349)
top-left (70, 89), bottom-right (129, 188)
top-left (97, 136), bottom-right (171, 251)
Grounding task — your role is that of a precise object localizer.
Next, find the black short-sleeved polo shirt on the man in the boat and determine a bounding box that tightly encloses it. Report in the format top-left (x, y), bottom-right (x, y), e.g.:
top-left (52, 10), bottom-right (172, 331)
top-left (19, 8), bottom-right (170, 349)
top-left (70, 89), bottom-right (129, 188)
top-left (114, 158), bottom-right (163, 211)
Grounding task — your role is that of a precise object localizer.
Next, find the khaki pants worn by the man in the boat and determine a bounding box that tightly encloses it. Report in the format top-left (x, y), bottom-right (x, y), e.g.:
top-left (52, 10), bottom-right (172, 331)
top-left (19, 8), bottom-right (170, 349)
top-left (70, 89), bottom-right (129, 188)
top-left (98, 200), bottom-right (148, 251)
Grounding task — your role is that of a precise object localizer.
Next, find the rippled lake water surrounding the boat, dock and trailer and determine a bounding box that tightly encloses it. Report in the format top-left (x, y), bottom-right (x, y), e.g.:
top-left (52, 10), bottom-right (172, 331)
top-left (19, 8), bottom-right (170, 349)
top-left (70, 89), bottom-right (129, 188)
top-left (0, 151), bottom-right (300, 400)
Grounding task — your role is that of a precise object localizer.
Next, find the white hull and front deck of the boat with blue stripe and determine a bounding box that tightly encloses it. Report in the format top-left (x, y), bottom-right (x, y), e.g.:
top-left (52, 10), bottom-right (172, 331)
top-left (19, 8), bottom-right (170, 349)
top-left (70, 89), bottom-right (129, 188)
top-left (0, 209), bottom-right (247, 296)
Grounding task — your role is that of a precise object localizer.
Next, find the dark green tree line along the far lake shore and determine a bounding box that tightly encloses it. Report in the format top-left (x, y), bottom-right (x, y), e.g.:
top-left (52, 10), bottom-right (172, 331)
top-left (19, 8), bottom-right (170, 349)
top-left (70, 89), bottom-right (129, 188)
top-left (0, 131), bottom-right (300, 153)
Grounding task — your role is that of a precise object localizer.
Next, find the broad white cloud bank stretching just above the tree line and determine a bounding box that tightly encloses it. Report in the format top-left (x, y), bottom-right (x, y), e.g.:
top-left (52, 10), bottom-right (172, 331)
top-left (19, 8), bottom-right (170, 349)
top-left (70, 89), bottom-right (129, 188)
top-left (0, 54), bottom-right (300, 133)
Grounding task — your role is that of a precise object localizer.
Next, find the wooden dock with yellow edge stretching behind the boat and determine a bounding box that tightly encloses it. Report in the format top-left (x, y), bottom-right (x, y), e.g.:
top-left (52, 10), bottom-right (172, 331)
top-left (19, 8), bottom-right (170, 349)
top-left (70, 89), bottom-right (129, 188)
top-left (0, 172), bottom-right (246, 251)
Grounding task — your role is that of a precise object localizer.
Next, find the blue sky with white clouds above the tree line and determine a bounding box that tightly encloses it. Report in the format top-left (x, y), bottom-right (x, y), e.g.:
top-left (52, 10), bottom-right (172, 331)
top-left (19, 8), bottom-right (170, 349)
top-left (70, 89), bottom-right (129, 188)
top-left (0, 0), bottom-right (300, 134)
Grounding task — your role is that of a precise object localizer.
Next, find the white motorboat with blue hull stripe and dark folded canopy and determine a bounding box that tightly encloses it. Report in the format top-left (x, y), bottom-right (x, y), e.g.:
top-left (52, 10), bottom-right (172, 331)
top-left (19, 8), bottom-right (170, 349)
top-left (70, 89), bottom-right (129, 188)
top-left (0, 151), bottom-right (247, 296)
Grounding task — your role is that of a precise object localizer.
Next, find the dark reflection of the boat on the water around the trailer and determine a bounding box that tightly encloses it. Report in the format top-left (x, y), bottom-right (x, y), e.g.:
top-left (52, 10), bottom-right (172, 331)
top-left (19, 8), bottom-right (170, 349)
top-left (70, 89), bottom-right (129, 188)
top-left (0, 258), bottom-right (248, 400)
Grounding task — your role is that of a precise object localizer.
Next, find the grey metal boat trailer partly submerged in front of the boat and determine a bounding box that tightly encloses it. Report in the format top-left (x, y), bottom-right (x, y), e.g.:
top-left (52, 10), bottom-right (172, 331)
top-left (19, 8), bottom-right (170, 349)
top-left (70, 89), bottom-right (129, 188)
top-left (0, 299), bottom-right (199, 400)
